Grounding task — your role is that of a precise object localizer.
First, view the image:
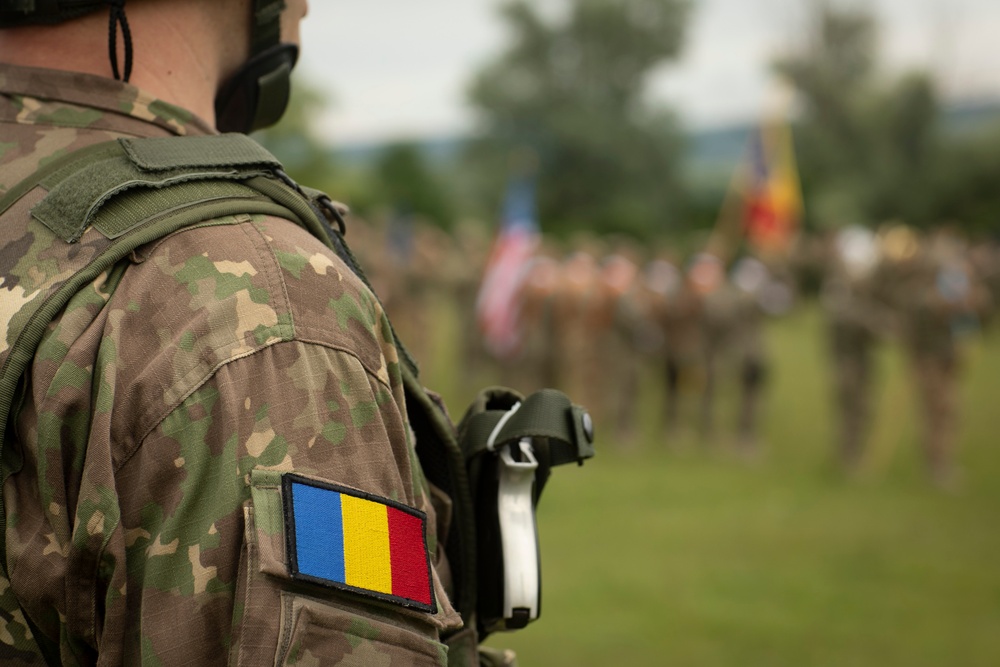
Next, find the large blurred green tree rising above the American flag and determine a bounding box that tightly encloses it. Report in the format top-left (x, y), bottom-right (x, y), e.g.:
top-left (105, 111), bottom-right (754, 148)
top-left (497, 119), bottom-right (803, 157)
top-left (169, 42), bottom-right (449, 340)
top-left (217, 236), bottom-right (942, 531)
top-left (468, 0), bottom-right (690, 235)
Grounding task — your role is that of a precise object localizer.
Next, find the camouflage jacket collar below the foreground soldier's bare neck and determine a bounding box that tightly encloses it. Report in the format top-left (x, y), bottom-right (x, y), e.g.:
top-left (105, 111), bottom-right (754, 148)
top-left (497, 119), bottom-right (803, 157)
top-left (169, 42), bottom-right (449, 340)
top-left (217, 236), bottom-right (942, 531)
top-left (0, 64), bottom-right (217, 135)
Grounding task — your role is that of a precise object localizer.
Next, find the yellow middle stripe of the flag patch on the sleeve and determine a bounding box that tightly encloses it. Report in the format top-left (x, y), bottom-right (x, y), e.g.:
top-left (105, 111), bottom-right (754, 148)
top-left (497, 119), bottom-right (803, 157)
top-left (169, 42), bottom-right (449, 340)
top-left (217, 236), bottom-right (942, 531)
top-left (340, 494), bottom-right (392, 594)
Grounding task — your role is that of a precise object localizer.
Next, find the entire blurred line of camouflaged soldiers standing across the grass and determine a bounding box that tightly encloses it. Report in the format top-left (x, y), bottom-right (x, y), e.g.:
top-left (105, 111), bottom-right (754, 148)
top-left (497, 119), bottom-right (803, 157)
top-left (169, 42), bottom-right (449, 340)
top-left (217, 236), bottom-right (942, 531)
top-left (358, 217), bottom-right (1000, 485)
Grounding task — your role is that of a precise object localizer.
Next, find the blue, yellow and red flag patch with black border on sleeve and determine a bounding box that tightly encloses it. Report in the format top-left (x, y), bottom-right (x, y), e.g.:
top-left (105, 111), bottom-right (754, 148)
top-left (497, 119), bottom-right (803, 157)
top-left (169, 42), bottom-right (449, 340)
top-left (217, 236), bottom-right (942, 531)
top-left (282, 474), bottom-right (437, 613)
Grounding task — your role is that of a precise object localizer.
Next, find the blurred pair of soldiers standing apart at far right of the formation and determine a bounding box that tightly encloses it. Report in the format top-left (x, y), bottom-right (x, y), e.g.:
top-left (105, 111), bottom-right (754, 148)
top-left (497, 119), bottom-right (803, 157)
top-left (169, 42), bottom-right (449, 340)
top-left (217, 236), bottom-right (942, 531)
top-left (821, 225), bottom-right (1000, 486)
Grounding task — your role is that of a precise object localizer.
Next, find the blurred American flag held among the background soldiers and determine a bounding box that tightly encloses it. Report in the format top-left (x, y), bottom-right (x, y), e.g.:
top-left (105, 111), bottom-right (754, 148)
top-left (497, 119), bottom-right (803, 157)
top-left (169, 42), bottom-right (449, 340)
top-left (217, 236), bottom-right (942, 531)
top-left (476, 177), bottom-right (540, 359)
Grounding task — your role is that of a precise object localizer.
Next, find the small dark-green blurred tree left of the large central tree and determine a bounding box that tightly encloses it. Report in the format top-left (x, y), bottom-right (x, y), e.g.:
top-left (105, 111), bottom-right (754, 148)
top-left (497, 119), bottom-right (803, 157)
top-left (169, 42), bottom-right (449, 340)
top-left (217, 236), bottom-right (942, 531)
top-left (374, 142), bottom-right (454, 229)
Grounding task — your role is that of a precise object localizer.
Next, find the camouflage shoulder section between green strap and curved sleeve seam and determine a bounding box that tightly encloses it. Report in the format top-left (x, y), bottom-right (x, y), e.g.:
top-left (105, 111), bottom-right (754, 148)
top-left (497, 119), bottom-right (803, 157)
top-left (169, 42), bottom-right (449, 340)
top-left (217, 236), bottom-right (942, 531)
top-left (105, 216), bottom-right (398, 444)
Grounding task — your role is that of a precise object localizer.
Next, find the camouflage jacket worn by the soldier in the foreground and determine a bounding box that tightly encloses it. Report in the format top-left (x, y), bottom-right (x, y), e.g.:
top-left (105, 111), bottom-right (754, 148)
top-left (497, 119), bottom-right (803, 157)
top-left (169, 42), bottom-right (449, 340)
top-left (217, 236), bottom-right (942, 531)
top-left (0, 65), bottom-right (461, 665)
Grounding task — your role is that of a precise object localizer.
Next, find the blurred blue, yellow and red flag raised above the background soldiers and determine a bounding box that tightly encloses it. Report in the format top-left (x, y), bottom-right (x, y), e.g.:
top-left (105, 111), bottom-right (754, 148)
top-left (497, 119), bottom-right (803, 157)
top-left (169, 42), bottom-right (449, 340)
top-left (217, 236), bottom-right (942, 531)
top-left (742, 123), bottom-right (802, 253)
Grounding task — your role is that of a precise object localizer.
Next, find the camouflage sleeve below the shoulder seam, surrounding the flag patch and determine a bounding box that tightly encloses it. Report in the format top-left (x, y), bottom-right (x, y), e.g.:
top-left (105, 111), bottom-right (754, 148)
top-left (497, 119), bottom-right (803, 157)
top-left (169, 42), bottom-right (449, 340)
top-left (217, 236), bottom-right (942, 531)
top-left (122, 341), bottom-right (458, 665)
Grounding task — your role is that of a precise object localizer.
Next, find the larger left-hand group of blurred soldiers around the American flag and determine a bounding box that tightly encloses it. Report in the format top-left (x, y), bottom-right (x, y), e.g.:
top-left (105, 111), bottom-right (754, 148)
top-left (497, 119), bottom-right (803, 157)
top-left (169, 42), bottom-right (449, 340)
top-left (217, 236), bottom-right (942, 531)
top-left (352, 224), bottom-right (795, 455)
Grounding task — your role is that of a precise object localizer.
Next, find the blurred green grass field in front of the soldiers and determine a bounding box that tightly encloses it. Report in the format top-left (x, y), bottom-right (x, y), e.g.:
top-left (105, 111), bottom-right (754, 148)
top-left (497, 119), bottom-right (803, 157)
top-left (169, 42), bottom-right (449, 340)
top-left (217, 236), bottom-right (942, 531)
top-left (425, 308), bottom-right (1000, 667)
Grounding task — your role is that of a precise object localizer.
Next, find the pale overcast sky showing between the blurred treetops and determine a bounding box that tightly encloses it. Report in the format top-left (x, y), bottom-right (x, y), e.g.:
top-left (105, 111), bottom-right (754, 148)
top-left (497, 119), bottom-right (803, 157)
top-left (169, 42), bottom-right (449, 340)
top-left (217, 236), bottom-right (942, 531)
top-left (300, 0), bottom-right (1000, 143)
